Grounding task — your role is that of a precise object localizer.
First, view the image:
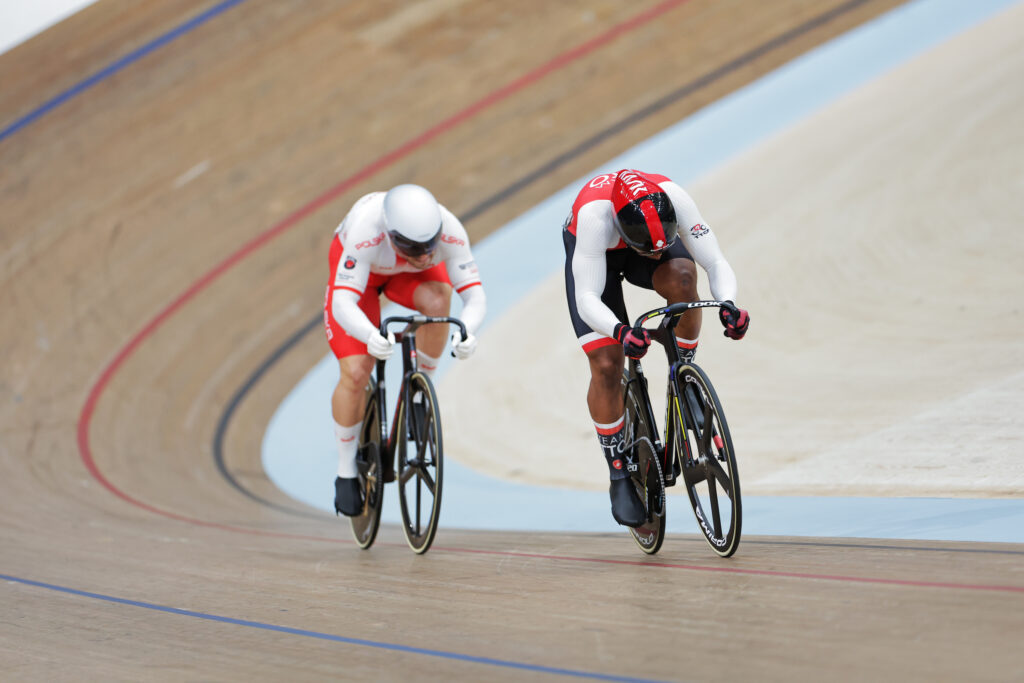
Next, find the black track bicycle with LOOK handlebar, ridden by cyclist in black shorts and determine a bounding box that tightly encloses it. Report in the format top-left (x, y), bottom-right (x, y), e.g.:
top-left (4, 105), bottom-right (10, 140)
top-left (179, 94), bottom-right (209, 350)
top-left (623, 301), bottom-right (742, 557)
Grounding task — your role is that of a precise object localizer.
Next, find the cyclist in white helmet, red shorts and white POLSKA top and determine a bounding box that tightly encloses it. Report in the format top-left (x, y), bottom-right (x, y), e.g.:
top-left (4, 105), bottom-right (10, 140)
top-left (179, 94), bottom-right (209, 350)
top-left (324, 184), bottom-right (486, 516)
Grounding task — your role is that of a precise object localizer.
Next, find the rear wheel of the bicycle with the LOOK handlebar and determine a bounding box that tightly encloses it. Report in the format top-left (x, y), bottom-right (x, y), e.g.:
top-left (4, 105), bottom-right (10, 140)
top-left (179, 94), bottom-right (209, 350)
top-left (623, 371), bottom-right (666, 555)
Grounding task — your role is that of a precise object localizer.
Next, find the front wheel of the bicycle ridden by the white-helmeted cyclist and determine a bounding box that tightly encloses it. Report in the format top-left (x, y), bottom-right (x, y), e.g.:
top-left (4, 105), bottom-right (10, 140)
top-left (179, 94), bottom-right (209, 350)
top-left (395, 372), bottom-right (444, 554)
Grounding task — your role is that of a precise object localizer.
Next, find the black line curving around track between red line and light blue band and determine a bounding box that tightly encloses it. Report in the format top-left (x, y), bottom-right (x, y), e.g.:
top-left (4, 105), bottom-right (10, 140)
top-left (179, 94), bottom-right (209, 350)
top-left (207, 0), bottom-right (1024, 555)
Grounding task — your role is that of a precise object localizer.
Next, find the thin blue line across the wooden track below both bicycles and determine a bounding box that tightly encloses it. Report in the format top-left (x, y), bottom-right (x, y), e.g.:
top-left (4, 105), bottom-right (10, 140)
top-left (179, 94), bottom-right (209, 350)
top-left (0, 573), bottom-right (658, 683)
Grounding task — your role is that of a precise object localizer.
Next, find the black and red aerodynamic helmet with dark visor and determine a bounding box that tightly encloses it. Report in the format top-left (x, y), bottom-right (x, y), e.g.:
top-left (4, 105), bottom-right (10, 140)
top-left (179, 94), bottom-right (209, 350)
top-left (611, 170), bottom-right (679, 254)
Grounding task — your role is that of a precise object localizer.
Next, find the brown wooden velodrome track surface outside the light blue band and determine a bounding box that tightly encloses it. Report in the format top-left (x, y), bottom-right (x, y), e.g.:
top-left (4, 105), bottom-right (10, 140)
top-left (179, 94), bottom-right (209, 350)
top-left (0, 0), bottom-right (1024, 680)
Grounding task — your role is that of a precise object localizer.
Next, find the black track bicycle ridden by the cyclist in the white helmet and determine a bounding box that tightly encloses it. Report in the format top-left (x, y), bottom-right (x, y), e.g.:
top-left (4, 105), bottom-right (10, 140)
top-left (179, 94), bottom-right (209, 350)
top-left (349, 315), bottom-right (467, 554)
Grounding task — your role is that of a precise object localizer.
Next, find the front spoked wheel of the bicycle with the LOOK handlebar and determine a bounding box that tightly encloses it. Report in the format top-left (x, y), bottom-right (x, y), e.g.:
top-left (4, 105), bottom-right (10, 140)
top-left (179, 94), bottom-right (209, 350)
top-left (672, 365), bottom-right (742, 557)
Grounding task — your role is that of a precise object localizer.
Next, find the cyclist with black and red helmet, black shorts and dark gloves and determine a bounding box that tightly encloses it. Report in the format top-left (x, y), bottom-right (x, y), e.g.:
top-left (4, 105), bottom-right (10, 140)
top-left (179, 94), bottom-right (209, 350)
top-left (562, 169), bottom-right (750, 527)
